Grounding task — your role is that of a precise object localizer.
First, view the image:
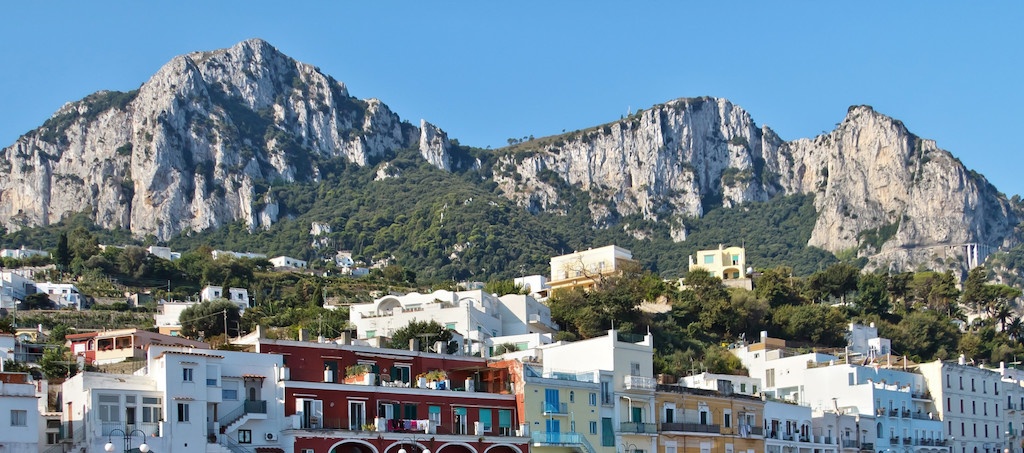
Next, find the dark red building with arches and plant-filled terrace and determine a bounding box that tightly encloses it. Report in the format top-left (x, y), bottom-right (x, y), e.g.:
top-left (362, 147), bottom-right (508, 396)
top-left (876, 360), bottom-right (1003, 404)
top-left (236, 330), bottom-right (529, 453)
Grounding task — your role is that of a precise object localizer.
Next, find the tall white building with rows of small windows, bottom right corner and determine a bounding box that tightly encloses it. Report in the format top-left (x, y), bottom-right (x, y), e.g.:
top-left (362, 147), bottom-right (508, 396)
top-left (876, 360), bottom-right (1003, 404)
top-left (921, 355), bottom-right (1020, 453)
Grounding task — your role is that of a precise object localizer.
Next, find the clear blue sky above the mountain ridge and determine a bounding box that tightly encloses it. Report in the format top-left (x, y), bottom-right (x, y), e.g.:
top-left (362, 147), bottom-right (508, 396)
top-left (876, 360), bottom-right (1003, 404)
top-left (6, 1), bottom-right (1024, 195)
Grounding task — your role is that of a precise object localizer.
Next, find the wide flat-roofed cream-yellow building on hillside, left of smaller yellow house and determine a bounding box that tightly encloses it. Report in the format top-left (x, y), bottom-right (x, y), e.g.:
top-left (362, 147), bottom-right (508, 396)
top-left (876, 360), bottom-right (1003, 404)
top-left (548, 245), bottom-right (635, 294)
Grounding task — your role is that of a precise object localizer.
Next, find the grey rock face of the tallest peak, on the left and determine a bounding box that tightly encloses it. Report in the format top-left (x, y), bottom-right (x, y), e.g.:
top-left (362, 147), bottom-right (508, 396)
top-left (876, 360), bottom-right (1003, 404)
top-left (0, 40), bottom-right (436, 239)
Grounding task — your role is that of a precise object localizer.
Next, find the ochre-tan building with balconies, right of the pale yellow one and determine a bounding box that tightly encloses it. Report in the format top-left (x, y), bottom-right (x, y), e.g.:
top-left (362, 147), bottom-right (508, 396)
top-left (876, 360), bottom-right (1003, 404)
top-left (655, 384), bottom-right (765, 453)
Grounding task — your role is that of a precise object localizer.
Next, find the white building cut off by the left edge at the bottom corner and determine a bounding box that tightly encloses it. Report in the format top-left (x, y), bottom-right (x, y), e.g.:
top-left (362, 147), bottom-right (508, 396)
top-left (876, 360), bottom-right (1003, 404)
top-left (0, 372), bottom-right (40, 453)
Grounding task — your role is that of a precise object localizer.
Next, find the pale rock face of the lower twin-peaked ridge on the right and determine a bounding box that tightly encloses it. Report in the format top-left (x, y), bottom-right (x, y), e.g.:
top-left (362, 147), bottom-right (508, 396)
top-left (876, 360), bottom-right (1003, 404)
top-left (487, 97), bottom-right (1019, 269)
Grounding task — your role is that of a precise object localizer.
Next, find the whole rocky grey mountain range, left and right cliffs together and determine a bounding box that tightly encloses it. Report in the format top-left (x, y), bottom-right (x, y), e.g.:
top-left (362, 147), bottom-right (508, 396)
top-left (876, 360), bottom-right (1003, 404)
top-left (0, 40), bottom-right (1019, 269)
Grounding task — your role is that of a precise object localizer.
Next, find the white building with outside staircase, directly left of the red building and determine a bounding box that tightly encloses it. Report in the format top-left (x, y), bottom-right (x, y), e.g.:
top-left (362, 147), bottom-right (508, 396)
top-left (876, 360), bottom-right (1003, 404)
top-left (62, 346), bottom-right (287, 453)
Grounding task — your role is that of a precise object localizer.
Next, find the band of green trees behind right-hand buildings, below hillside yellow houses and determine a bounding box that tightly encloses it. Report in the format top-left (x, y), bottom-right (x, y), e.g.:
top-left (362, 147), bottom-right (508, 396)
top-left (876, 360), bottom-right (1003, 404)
top-left (550, 263), bottom-right (1024, 375)
